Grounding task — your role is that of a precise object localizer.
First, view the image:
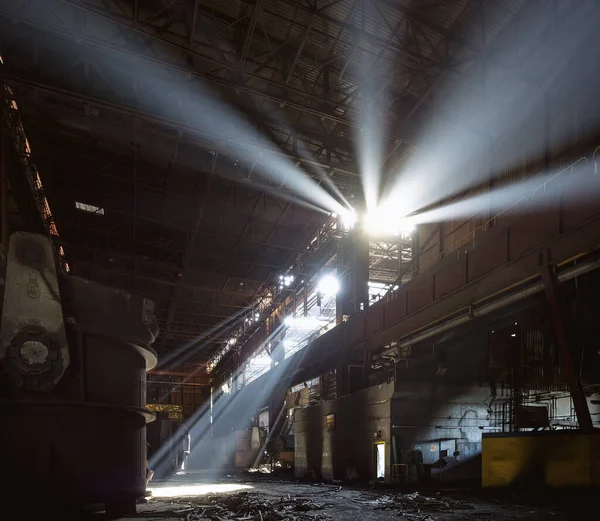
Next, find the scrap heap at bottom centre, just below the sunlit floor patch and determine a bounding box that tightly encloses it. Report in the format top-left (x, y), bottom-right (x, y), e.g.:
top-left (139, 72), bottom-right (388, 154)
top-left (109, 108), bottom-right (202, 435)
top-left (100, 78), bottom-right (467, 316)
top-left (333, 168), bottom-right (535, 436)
top-left (176, 492), bottom-right (332, 521)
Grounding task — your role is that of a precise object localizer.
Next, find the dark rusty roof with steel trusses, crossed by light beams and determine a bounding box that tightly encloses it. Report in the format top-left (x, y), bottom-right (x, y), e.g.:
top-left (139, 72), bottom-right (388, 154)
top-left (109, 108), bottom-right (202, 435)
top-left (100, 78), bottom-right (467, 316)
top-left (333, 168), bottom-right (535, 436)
top-left (0, 0), bottom-right (528, 370)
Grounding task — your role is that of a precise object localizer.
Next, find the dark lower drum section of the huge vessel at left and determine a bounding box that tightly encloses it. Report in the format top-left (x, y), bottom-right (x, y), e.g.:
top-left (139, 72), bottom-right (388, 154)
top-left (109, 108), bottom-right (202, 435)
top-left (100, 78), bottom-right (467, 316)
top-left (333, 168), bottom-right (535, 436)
top-left (0, 404), bottom-right (146, 511)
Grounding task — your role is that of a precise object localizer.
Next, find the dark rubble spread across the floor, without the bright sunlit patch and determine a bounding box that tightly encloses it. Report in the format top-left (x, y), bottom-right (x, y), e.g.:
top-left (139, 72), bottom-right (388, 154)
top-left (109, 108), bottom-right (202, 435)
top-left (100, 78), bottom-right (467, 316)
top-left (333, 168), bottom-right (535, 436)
top-left (137, 481), bottom-right (580, 521)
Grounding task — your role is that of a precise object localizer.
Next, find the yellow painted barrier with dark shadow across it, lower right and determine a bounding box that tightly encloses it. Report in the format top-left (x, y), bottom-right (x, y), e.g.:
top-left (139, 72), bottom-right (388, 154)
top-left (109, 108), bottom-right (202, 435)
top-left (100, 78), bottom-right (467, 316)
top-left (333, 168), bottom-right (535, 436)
top-left (481, 430), bottom-right (600, 488)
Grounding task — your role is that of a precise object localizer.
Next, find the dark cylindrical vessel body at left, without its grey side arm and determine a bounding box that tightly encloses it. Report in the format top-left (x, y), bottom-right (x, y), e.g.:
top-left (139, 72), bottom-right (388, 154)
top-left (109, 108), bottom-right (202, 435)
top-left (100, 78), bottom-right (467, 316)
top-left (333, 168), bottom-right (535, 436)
top-left (0, 234), bottom-right (158, 513)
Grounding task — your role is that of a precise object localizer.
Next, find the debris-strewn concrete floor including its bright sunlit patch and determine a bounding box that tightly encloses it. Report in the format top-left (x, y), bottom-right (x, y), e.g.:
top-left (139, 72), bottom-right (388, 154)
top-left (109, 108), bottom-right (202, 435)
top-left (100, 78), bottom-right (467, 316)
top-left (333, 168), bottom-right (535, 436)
top-left (126, 472), bottom-right (597, 521)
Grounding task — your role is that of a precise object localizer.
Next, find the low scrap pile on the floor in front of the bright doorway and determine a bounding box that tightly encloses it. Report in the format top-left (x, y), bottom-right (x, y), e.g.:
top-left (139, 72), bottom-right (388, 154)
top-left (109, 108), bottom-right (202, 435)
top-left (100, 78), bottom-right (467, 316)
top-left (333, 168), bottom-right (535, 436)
top-left (353, 492), bottom-right (473, 521)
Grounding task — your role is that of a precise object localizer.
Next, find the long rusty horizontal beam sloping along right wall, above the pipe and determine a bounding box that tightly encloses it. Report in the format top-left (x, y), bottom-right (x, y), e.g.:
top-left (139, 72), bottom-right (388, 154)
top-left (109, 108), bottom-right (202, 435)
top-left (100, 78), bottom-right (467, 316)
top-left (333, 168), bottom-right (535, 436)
top-left (248, 201), bottom-right (600, 390)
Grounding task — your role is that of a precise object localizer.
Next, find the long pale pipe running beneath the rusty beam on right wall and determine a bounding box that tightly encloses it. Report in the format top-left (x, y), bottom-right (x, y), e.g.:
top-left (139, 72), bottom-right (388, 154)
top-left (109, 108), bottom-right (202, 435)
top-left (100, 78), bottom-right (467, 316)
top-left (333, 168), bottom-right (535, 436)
top-left (398, 258), bottom-right (600, 347)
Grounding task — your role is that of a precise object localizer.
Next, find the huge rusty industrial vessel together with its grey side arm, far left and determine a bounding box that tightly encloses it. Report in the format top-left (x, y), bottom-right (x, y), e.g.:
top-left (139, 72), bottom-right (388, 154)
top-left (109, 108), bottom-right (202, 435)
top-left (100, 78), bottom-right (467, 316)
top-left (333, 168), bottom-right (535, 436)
top-left (0, 232), bottom-right (158, 514)
